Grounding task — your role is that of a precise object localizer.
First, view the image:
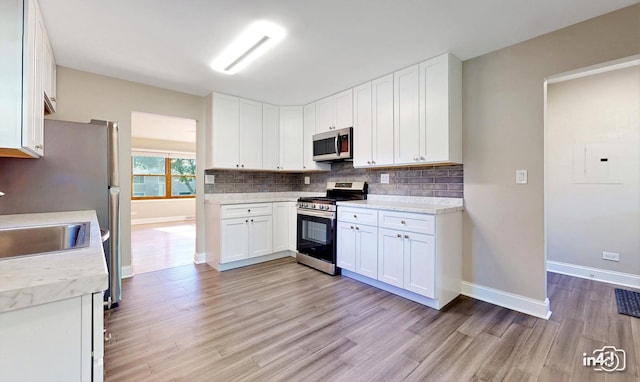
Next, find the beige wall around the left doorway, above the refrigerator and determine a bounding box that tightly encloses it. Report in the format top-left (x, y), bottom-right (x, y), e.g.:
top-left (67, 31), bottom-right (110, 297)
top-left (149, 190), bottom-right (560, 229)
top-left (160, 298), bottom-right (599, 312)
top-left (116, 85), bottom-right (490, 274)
top-left (49, 67), bottom-right (204, 266)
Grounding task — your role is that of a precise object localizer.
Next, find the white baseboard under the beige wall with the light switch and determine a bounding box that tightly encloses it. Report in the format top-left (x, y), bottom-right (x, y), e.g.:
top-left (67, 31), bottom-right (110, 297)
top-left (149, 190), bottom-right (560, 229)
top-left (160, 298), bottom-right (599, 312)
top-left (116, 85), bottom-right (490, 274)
top-left (462, 281), bottom-right (551, 320)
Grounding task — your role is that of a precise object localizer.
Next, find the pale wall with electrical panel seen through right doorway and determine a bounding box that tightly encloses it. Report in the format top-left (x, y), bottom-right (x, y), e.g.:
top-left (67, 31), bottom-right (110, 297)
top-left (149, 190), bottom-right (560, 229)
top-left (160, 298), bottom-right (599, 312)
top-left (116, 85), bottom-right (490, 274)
top-left (545, 65), bottom-right (640, 275)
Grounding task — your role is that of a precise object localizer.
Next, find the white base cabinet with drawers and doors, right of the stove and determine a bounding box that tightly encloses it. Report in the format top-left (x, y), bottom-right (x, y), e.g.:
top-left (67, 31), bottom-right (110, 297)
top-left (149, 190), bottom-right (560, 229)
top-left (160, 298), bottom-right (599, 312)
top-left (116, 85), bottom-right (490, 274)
top-left (337, 206), bottom-right (462, 309)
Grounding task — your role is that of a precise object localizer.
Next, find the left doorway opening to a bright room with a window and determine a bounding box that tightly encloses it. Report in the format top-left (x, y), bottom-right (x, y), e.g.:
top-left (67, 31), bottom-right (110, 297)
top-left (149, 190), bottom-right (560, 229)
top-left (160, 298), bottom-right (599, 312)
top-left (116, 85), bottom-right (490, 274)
top-left (131, 112), bottom-right (197, 274)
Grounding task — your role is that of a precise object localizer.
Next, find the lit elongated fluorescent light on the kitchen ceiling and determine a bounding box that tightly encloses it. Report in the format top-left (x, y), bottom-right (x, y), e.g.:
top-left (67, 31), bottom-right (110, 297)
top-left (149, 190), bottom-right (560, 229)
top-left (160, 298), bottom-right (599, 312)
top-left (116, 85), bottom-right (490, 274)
top-left (211, 21), bottom-right (287, 74)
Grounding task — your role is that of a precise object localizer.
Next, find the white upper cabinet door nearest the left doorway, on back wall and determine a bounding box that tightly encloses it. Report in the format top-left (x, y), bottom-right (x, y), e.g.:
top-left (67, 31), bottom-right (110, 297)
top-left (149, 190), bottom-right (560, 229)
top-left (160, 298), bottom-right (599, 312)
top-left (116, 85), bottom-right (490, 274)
top-left (210, 93), bottom-right (240, 169)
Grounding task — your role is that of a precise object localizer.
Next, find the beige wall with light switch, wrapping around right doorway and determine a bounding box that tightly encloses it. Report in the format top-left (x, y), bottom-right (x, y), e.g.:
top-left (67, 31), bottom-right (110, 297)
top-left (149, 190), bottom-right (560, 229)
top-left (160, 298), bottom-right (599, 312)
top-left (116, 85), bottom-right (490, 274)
top-left (462, 5), bottom-right (640, 301)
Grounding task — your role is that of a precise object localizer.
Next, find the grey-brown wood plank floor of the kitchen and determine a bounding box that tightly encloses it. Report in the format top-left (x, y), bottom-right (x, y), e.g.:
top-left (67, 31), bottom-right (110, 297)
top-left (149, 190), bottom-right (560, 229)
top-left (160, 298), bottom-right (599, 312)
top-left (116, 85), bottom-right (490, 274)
top-left (105, 258), bottom-right (640, 382)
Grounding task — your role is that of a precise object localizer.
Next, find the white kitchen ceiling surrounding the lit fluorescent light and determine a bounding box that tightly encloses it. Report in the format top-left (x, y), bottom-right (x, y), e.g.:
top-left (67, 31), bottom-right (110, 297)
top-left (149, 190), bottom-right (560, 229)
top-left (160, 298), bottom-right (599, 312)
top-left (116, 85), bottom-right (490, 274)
top-left (40, 0), bottom-right (639, 105)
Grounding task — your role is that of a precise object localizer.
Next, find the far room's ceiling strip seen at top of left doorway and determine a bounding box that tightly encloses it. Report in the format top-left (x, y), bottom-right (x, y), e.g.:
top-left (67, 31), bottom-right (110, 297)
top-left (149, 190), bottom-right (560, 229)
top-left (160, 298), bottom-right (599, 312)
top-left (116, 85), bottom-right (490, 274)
top-left (131, 111), bottom-right (196, 143)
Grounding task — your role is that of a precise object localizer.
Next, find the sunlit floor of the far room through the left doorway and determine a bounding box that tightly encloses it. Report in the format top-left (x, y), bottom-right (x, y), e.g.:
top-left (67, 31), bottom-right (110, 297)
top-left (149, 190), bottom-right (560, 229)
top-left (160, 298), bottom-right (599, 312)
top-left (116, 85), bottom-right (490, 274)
top-left (131, 221), bottom-right (196, 274)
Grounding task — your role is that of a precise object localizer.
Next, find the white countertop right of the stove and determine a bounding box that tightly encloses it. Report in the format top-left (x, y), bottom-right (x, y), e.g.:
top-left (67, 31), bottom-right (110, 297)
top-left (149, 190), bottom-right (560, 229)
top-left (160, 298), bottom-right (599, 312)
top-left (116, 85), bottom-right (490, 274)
top-left (338, 194), bottom-right (464, 215)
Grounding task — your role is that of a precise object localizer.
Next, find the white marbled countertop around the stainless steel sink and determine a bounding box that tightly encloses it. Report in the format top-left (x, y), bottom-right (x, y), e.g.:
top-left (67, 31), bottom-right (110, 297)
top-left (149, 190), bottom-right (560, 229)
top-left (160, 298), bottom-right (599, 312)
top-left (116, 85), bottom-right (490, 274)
top-left (0, 211), bottom-right (109, 312)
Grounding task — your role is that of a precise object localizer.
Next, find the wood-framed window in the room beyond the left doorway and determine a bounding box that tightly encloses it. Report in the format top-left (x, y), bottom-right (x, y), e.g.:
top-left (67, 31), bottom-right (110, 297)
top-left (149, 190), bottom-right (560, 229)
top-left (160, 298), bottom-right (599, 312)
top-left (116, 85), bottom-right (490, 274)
top-left (131, 154), bottom-right (196, 200)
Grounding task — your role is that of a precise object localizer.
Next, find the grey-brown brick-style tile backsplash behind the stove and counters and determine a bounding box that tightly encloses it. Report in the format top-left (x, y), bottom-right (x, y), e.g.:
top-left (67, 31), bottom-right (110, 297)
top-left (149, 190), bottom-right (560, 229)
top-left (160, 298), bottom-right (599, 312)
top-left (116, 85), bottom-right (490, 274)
top-left (205, 162), bottom-right (464, 198)
